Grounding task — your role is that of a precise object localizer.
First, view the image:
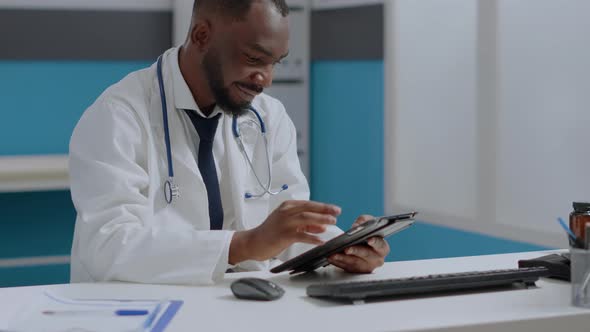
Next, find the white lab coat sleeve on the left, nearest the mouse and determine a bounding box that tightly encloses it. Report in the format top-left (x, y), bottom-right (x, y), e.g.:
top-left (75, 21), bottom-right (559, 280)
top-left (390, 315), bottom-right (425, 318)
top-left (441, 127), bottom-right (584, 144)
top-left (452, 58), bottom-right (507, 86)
top-left (70, 101), bottom-right (233, 284)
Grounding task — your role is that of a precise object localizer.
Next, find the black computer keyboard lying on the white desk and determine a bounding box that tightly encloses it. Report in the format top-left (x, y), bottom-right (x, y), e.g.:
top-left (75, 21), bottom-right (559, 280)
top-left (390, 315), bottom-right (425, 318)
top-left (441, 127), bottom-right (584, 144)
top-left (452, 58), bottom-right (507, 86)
top-left (307, 267), bottom-right (549, 301)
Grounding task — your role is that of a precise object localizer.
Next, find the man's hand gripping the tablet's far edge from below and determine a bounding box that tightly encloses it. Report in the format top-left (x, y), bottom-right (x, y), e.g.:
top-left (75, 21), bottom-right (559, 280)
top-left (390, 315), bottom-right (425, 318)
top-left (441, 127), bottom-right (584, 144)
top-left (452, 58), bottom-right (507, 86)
top-left (328, 215), bottom-right (389, 273)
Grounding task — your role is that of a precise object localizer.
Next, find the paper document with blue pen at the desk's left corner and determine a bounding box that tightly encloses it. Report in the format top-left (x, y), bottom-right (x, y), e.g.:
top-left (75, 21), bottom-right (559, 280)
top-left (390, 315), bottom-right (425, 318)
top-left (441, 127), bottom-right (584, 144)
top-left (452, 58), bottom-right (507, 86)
top-left (9, 292), bottom-right (183, 332)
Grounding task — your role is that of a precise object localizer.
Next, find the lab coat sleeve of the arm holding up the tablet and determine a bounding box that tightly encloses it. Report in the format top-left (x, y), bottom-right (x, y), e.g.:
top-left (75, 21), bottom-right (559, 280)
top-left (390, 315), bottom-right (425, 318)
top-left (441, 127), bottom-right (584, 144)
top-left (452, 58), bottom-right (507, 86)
top-left (270, 101), bottom-right (342, 261)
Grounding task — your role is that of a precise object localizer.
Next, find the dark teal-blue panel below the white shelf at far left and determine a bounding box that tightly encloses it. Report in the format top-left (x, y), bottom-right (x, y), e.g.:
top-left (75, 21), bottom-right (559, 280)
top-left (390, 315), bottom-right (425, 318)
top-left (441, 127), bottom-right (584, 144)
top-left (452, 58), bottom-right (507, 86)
top-left (0, 191), bottom-right (76, 287)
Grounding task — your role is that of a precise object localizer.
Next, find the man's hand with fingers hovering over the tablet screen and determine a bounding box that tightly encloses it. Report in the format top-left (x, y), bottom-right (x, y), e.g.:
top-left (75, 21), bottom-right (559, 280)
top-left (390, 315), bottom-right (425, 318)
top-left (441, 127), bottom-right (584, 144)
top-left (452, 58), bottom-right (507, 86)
top-left (229, 201), bottom-right (341, 264)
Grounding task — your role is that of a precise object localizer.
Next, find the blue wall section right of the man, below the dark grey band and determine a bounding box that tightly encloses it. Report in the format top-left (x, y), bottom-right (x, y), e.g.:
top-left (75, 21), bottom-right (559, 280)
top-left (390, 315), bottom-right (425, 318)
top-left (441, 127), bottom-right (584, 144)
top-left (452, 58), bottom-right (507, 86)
top-left (310, 61), bottom-right (384, 229)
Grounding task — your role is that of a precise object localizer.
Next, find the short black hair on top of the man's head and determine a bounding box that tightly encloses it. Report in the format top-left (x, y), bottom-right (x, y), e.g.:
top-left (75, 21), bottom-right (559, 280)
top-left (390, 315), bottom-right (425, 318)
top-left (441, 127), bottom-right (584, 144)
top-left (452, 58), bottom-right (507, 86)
top-left (193, 0), bottom-right (289, 20)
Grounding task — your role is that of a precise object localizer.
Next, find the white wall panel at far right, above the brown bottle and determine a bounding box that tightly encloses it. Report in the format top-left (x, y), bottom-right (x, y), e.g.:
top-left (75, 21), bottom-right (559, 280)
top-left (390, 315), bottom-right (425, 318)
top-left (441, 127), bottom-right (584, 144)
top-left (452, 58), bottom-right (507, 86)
top-left (496, 0), bottom-right (590, 239)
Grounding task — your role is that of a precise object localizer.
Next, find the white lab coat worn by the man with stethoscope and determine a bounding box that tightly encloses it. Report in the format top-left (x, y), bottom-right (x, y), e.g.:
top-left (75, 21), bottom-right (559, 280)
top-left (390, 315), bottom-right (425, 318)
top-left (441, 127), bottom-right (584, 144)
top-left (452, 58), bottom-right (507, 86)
top-left (69, 49), bottom-right (341, 284)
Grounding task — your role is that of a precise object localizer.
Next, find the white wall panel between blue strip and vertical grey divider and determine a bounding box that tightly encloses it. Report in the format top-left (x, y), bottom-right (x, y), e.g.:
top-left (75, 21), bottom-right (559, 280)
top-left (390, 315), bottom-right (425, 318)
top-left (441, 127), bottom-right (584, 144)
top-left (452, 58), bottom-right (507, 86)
top-left (387, 0), bottom-right (476, 218)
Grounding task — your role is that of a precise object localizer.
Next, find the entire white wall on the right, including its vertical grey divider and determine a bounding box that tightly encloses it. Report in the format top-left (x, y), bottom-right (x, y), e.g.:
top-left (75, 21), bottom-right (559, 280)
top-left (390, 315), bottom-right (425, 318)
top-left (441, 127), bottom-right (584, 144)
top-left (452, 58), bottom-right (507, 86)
top-left (385, 0), bottom-right (590, 246)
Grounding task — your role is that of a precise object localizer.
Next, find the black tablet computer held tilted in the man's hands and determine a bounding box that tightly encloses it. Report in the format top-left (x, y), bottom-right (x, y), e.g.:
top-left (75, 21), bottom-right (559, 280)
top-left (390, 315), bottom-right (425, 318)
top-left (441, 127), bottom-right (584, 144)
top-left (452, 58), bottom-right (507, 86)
top-left (270, 212), bottom-right (417, 274)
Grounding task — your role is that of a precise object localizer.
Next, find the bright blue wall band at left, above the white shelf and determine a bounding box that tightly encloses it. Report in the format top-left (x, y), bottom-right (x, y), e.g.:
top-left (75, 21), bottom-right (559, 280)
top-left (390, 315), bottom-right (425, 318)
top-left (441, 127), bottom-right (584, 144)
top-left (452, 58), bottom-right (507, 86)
top-left (0, 61), bottom-right (150, 155)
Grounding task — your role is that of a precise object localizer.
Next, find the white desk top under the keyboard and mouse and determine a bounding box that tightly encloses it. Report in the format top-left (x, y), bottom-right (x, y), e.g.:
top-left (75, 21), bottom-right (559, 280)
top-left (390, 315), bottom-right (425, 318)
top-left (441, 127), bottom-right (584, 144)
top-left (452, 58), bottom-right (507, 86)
top-left (0, 252), bottom-right (590, 332)
